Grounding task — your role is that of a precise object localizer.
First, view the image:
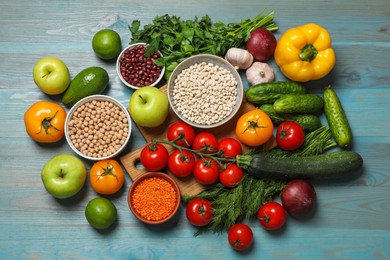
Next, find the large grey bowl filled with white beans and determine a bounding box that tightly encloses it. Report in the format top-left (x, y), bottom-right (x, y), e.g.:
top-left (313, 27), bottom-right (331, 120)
top-left (167, 54), bottom-right (244, 128)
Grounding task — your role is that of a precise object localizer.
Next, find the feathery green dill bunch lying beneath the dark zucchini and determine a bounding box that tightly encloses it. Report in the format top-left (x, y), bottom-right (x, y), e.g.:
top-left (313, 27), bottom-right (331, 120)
top-left (184, 125), bottom-right (336, 236)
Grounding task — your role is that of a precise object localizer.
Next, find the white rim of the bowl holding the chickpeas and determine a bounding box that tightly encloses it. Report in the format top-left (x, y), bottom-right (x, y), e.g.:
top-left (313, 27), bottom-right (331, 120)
top-left (65, 95), bottom-right (132, 161)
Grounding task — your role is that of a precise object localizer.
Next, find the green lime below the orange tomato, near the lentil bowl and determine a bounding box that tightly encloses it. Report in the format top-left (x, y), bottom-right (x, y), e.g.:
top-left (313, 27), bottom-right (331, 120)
top-left (85, 198), bottom-right (117, 229)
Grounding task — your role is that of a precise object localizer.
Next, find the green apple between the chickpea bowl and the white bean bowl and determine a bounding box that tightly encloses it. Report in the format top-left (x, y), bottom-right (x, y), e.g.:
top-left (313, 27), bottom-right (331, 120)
top-left (128, 86), bottom-right (169, 127)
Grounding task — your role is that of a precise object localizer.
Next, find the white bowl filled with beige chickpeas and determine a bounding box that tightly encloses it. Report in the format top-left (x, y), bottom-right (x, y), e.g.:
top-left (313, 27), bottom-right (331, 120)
top-left (65, 95), bottom-right (131, 161)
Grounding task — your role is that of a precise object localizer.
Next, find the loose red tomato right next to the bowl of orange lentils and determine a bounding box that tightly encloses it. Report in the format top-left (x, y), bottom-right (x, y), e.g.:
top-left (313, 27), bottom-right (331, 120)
top-left (186, 198), bottom-right (214, 227)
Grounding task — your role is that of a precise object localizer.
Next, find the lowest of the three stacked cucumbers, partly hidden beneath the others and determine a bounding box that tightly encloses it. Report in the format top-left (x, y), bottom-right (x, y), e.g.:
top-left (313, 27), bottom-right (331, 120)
top-left (260, 104), bottom-right (322, 133)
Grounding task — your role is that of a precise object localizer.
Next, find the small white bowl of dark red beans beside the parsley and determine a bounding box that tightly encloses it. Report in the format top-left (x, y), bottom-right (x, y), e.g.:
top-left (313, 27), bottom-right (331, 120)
top-left (116, 43), bottom-right (165, 89)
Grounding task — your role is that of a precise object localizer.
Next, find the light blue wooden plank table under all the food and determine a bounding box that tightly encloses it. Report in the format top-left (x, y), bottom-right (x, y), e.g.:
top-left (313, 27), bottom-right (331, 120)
top-left (0, 0), bottom-right (390, 259)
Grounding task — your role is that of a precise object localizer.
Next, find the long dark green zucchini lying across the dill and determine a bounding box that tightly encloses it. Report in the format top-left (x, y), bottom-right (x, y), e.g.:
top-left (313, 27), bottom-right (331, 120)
top-left (237, 151), bottom-right (363, 179)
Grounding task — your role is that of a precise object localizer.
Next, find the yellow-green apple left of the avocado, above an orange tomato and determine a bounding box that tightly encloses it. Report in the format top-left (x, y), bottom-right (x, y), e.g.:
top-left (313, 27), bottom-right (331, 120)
top-left (33, 57), bottom-right (70, 95)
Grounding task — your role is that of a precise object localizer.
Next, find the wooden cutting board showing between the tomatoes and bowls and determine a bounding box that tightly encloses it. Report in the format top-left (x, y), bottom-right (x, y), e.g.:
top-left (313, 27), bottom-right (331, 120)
top-left (120, 85), bottom-right (274, 196)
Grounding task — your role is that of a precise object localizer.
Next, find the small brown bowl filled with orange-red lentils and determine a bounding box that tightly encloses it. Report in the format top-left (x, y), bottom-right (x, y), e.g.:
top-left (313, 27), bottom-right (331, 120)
top-left (127, 172), bottom-right (181, 225)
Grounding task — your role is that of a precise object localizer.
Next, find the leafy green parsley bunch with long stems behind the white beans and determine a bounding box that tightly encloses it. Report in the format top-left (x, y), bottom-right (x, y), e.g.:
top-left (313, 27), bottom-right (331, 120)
top-left (129, 11), bottom-right (278, 80)
